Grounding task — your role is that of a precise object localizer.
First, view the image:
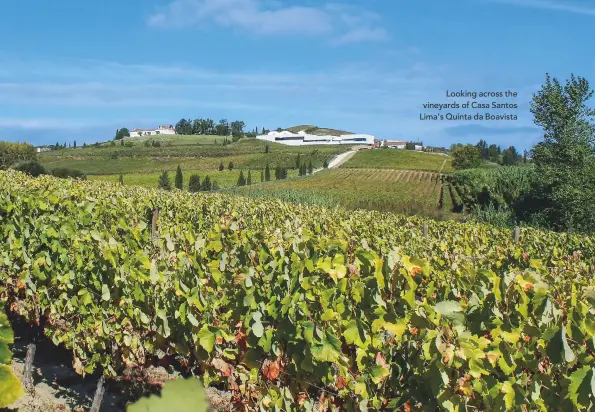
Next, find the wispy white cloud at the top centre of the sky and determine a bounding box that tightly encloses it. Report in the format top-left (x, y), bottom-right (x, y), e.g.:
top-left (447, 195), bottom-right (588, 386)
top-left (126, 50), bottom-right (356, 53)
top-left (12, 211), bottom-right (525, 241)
top-left (148, 0), bottom-right (388, 44)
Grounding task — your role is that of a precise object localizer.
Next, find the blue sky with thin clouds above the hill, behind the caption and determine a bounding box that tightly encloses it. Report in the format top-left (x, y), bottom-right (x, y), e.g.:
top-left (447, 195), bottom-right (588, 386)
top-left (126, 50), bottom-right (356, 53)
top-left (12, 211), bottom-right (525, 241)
top-left (0, 0), bottom-right (595, 148)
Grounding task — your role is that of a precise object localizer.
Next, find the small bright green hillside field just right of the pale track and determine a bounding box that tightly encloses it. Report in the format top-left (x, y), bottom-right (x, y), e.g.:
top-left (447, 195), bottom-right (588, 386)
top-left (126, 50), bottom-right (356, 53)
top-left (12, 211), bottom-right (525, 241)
top-left (341, 149), bottom-right (454, 173)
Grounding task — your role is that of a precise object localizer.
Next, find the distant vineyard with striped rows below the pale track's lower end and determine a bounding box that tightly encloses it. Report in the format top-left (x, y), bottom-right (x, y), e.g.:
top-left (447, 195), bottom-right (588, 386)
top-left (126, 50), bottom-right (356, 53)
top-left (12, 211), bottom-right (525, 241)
top-left (230, 169), bottom-right (450, 217)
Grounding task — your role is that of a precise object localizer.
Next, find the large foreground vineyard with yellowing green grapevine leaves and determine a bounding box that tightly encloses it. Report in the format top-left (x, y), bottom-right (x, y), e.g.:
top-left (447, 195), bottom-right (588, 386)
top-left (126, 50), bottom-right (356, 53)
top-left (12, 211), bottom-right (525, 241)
top-left (0, 171), bottom-right (595, 411)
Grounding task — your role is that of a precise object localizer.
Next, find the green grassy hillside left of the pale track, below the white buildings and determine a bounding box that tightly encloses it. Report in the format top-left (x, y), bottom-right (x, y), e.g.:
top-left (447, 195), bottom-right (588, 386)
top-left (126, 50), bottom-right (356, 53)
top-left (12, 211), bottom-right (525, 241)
top-left (40, 135), bottom-right (346, 175)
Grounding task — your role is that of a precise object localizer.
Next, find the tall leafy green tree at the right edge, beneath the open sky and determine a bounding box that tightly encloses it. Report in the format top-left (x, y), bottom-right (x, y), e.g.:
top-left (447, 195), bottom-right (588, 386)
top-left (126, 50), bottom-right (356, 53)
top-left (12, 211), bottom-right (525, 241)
top-left (516, 74), bottom-right (595, 233)
